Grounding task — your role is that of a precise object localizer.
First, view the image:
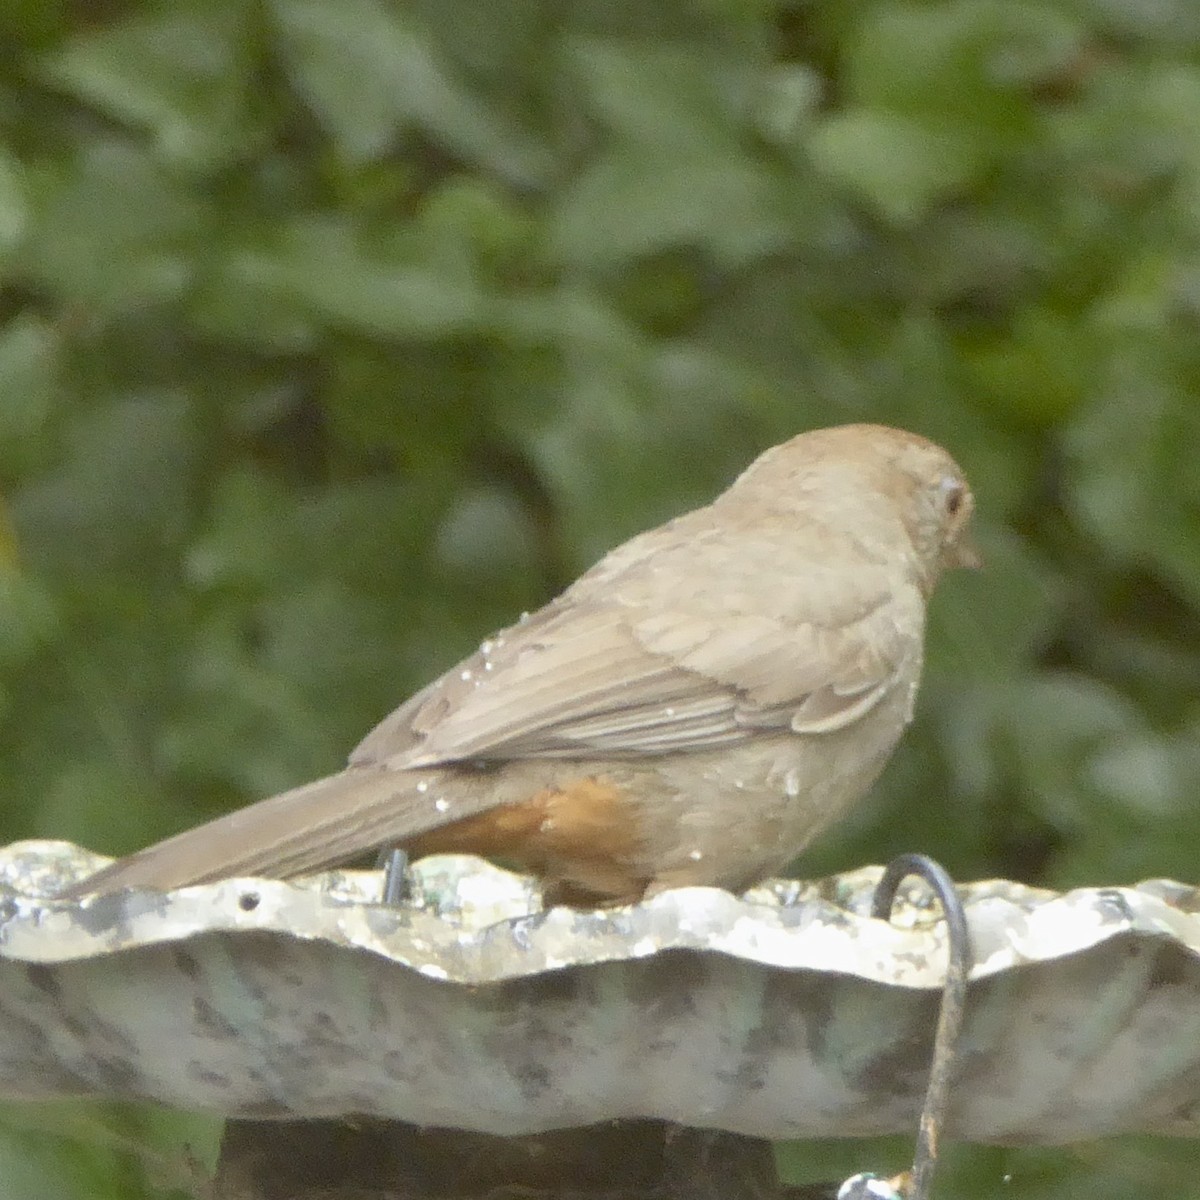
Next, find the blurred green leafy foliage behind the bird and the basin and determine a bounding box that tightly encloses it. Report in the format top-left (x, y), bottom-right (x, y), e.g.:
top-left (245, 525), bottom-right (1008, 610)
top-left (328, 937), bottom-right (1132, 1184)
top-left (0, 0), bottom-right (1200, 1200)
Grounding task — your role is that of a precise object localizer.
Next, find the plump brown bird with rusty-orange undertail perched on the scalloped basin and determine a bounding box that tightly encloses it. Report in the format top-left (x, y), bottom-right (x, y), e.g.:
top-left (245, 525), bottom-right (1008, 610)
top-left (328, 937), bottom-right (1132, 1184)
top-left (65, 425), bottom-right (977, 900)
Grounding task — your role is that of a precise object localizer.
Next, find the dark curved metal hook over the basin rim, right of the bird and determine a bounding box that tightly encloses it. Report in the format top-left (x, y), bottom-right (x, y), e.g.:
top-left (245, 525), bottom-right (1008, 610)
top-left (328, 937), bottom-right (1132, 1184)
top-left (871, 854), bottom-right (973, 1200)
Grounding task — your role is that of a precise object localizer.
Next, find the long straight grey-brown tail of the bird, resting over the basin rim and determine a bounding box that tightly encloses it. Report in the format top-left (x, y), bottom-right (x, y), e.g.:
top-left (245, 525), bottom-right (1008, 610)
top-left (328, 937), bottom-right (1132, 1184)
top-left (62, 767), bottom-right (497, 898)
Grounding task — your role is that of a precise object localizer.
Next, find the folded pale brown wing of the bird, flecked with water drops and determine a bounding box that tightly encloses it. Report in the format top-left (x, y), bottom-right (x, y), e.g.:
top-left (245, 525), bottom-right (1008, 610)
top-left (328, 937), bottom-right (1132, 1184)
top-left (352, 552), bottom-right (923, 768)
